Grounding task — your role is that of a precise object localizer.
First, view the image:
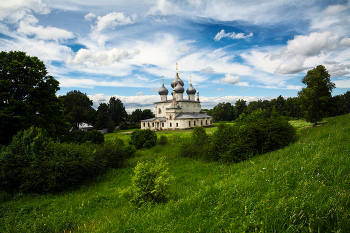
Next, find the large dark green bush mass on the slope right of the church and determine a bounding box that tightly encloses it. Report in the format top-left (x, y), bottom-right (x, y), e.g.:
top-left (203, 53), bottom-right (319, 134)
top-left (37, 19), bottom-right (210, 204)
top-left (204, 113), bottom-right (296, 162)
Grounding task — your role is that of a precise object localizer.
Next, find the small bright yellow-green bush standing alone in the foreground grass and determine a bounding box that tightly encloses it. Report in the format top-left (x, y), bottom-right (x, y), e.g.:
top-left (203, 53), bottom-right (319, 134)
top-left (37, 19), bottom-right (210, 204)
top-left (123, 157), bottom-right (174, 207)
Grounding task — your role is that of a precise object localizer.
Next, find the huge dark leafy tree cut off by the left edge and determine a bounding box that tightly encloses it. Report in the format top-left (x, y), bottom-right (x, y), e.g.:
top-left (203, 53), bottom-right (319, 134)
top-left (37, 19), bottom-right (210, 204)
top-left (0, 51), bottom-right (68, 145)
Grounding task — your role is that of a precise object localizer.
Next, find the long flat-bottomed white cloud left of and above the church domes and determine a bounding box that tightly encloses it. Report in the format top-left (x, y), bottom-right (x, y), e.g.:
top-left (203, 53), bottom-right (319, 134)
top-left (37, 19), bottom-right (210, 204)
top-left (67, 48), bottom-right (140, 67)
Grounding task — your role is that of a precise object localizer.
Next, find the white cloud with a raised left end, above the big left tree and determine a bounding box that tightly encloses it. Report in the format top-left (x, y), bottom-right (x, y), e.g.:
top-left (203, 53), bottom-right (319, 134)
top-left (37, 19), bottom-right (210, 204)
top-left (17, 15), bottom-right (75, 41)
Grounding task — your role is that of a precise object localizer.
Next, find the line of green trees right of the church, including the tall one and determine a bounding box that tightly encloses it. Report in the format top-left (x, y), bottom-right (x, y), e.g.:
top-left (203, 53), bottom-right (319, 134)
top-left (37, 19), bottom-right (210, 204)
top-left (207, 65), bottom-right (350, 124)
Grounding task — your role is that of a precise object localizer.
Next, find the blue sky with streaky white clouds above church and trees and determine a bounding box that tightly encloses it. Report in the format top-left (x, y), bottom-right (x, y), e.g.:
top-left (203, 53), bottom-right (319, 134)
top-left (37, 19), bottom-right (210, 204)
top-left (0, 0), bottom-right (350, 113)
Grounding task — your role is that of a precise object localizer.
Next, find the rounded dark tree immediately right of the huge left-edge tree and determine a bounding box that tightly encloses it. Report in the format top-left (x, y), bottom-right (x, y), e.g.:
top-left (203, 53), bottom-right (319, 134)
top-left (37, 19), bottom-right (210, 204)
top-left (60, 90), bottom-right (95, 129)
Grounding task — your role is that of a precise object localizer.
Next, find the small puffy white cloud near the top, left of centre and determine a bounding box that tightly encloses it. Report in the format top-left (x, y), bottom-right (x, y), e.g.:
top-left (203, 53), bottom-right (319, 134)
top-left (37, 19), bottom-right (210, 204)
top-left (94, 12), bottom-right (133, 32)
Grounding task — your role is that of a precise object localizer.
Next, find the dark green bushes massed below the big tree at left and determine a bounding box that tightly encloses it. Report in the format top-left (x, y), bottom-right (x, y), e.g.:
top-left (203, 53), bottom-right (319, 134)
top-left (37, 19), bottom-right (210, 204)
top-left (0, 127), bottom-right (135, 193)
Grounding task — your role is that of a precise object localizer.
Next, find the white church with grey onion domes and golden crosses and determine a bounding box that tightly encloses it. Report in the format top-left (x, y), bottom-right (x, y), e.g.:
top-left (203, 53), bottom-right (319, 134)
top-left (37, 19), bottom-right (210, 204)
top-left (141, 63), bottom-right (213, 130)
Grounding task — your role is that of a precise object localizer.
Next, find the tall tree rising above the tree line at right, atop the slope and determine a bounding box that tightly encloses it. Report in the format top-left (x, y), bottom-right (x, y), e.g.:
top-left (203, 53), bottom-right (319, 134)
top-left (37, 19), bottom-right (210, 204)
top-left (298, 65), bottom-right (335, 127)
